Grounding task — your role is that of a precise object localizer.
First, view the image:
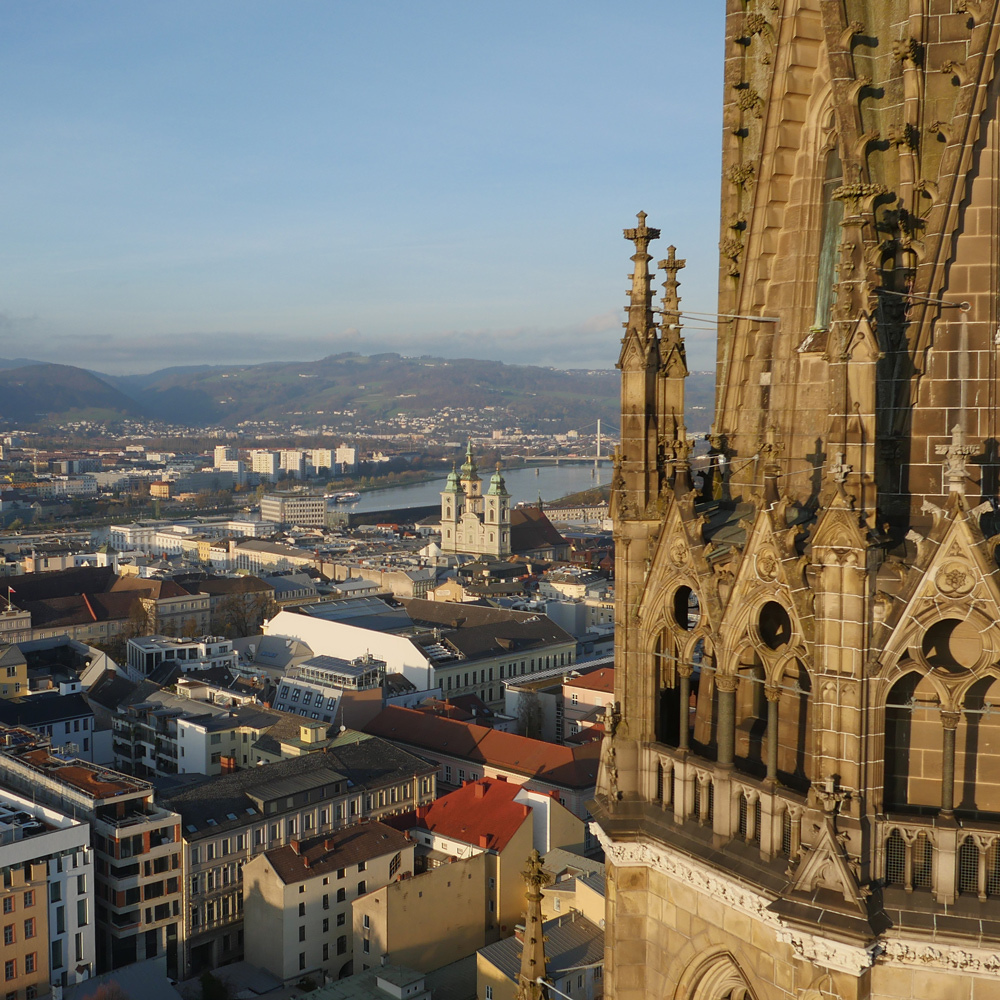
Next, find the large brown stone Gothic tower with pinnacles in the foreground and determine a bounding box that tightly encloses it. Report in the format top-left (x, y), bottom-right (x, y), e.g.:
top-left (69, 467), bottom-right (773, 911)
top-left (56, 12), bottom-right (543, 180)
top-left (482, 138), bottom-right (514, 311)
top-left (593, 0), bottom-right (1000, 1000)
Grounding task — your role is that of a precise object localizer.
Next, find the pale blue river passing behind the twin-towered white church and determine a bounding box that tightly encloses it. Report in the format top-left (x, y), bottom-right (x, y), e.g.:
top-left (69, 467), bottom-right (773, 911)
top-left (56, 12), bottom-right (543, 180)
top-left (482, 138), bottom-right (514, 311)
top-left (338, 462), bottom-right (611, 512)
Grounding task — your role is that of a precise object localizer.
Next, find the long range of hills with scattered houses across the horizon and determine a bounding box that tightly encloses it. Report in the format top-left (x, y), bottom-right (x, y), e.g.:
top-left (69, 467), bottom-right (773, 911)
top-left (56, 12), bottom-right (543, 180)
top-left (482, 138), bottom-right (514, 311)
top-left (0, 354), bottom-right (715, 434)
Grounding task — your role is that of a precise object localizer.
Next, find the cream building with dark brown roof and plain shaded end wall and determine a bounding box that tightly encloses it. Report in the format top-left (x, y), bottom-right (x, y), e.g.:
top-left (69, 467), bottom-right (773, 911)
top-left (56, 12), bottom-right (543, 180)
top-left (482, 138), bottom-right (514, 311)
top-left (243, 823), bottom-right (413, 984)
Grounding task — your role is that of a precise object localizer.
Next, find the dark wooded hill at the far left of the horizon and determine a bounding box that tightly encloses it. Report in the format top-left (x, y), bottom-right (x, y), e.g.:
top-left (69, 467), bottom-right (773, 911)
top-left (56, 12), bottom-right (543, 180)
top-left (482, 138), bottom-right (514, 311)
top-left (0, 362), bottom-right (143, 424)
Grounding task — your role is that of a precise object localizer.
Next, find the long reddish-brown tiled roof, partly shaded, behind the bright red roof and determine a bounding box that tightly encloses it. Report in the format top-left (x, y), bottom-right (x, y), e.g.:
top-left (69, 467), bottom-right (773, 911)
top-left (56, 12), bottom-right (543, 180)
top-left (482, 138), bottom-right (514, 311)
top-left (365, 705), bottom-right (600, 789)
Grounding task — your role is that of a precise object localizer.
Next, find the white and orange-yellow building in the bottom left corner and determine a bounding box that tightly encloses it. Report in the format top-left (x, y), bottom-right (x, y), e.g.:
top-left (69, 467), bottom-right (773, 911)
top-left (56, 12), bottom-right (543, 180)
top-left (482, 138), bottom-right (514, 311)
top-left (0, 788), bottom-right (96, 1000)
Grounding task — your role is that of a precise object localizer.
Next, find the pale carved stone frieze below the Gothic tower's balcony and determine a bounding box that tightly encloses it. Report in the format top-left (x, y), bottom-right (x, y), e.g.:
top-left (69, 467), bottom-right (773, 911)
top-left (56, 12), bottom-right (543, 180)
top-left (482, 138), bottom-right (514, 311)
top-left (590, 822), bottom-right (879, 976)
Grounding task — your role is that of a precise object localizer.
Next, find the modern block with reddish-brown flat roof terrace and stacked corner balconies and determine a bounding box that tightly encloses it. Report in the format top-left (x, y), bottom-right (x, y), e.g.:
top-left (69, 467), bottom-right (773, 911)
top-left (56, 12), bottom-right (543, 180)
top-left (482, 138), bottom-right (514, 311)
top-left (0, 730), bottom-right (182, 971)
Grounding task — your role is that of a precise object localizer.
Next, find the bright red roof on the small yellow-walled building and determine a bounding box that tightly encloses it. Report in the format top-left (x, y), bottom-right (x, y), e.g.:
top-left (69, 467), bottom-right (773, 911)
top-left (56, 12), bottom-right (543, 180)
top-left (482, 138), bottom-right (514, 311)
top-left (413, 778), bottom-right (531, 851)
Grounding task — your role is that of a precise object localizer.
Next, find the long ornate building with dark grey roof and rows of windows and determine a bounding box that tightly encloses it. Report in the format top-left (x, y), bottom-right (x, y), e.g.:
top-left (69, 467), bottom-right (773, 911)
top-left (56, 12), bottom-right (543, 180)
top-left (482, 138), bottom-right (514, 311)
top-left (160, 732), bottom-right (437, 978)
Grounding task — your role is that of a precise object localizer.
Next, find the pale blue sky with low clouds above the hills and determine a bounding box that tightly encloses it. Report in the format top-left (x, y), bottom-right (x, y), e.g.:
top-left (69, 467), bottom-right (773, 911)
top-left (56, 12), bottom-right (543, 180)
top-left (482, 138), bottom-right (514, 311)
top-left (0, 0), bottom-right (724, 373)
